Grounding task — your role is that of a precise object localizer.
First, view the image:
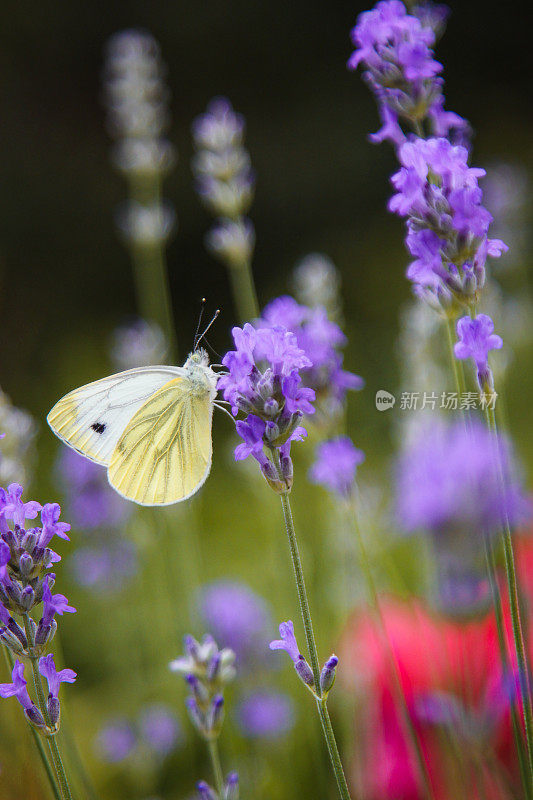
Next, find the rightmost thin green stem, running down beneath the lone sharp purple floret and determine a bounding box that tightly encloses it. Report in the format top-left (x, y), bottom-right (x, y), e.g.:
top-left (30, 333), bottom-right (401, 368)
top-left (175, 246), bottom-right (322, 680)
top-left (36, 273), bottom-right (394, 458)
top-left (485, 404), bottom-right (533, 781)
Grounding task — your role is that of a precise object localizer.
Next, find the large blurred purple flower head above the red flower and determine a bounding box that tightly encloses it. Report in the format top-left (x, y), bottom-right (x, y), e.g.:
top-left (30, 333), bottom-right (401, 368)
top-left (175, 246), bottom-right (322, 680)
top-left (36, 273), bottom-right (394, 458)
top-left (396, 420), bottom-right (530, 537)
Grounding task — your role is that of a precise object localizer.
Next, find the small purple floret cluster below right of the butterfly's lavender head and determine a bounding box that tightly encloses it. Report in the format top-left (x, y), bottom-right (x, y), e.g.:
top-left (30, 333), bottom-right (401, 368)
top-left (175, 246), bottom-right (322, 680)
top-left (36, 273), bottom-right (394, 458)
top-left (309, 436), bottom-right (365, 498)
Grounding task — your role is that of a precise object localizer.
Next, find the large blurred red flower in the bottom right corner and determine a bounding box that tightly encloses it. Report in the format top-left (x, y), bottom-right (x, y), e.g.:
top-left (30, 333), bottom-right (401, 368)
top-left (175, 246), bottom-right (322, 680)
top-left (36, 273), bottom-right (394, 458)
top-left (339, 544), bottom-right (533, 800)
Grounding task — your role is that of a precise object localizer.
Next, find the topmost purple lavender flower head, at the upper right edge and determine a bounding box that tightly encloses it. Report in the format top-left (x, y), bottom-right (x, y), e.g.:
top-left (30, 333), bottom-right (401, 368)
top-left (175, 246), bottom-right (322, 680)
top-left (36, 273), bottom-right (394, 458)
top-left (348, 0), bottom-right (469, 147)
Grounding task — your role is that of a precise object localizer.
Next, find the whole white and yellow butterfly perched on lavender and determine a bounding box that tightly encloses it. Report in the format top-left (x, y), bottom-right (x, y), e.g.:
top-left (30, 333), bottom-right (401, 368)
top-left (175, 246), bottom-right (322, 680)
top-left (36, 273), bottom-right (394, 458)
top-left (47, 348), bottom-right (218, 506)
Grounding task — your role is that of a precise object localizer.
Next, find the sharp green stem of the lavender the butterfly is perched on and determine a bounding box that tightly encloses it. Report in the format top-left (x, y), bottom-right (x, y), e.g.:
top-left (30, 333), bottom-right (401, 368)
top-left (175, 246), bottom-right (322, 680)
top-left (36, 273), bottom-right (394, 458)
top-left (271, 447), bottom-right (351, 800)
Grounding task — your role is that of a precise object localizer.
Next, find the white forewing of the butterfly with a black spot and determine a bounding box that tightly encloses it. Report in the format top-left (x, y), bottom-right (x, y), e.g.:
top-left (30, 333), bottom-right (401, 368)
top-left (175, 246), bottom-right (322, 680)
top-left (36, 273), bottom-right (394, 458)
top-left (47, 366), bottom-right (184, 466)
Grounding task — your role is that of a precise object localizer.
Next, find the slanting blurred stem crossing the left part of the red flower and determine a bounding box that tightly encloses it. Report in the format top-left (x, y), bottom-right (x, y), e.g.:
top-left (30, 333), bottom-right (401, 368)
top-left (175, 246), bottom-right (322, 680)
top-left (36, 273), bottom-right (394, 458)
top-left (352, 494), bottom-right (435, 798)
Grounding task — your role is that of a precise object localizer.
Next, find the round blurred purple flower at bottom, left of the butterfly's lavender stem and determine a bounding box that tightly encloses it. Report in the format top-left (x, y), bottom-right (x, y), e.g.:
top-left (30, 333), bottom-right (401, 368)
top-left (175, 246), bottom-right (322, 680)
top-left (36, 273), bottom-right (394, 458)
top-left (237, 689), bottom-right (294, 739)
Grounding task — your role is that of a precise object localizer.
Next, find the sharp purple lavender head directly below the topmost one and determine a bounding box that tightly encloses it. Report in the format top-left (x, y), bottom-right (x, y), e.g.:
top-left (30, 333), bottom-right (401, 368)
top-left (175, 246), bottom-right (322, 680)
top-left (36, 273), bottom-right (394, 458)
top-left (389, 138), bottom-right (507, 309)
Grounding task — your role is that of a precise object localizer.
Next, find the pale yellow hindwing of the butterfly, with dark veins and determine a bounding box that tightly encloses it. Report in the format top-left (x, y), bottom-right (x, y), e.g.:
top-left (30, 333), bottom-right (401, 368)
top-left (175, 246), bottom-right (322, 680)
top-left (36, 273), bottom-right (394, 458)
top-left (108, 377), bottom-right (213, 506)
